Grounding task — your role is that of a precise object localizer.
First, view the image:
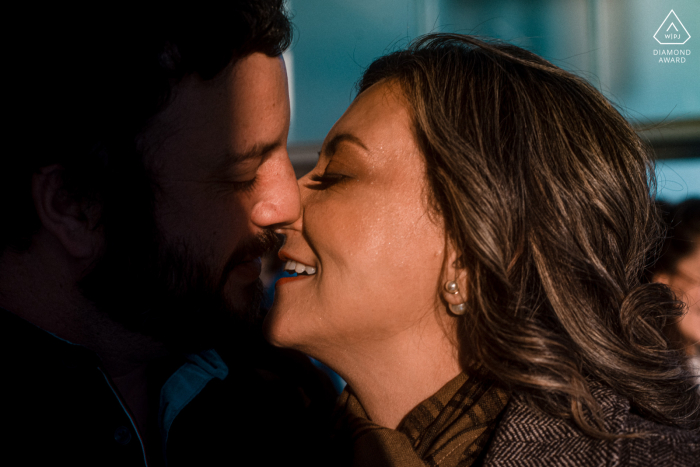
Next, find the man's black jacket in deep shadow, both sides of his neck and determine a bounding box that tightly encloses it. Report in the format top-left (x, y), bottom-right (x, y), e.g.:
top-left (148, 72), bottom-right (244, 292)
top-left (0, 309), bottom-right (335, 467)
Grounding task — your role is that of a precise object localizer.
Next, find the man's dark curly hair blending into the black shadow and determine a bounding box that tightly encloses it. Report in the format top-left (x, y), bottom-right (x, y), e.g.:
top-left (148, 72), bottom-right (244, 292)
top-left (0, 0), bottom-right (292, 253)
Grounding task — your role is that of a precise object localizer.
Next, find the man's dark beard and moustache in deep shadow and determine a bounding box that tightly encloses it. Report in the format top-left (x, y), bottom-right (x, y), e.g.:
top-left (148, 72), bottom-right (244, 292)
top-left (80, 219), bottom-right (278, 353)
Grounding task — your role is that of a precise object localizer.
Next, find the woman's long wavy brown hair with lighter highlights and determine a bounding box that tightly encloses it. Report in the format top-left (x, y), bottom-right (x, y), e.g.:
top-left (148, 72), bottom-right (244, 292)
top-left (358, 34), bottom-right (700, 438)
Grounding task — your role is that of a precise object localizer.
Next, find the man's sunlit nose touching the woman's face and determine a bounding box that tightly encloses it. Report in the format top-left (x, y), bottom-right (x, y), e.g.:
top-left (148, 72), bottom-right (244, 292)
top-left (251, 151), bottom-right (301, 229)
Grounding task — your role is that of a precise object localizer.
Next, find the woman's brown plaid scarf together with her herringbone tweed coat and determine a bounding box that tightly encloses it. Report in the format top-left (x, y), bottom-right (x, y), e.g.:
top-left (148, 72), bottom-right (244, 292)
top-left (335, 376), bottom-right (700, 467)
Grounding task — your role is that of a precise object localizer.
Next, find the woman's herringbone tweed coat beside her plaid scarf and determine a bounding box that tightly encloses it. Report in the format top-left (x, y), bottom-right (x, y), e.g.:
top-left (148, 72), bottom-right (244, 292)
top-left (484, 386), bottom-right (700, 467)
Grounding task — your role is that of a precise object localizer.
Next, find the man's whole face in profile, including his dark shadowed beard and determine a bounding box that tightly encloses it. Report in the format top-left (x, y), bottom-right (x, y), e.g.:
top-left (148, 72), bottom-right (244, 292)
top-left (86, 53), bottom-right (300, 350)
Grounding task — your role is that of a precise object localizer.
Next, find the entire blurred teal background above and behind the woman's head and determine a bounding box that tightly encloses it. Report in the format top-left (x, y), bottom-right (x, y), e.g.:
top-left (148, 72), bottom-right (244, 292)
top-left (285, 0), bottom-right (700, 202)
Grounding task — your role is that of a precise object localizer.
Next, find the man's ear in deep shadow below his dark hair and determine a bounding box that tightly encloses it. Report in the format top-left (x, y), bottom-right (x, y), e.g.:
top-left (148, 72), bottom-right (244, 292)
top-left (32, 164), bottom-right (102, 259)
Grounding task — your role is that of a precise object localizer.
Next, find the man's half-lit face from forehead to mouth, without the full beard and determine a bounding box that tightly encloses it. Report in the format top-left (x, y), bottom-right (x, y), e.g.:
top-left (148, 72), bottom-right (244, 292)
top-left (148, 53), bottom-right (300, 309)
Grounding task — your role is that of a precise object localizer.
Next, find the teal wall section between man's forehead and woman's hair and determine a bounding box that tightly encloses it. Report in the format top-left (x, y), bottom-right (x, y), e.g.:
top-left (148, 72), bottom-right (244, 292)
top-left (287, 0), bottom-right (420, 143)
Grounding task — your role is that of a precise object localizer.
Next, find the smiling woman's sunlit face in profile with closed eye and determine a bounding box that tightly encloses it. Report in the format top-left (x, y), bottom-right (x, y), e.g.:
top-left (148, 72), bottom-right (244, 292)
top-left (265, 83), bottom-right (445, 364)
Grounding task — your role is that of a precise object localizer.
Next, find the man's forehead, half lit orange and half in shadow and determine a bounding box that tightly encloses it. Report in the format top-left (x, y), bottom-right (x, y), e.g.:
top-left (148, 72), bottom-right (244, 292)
top-left (143, 54), bottom-right (289, 176)
